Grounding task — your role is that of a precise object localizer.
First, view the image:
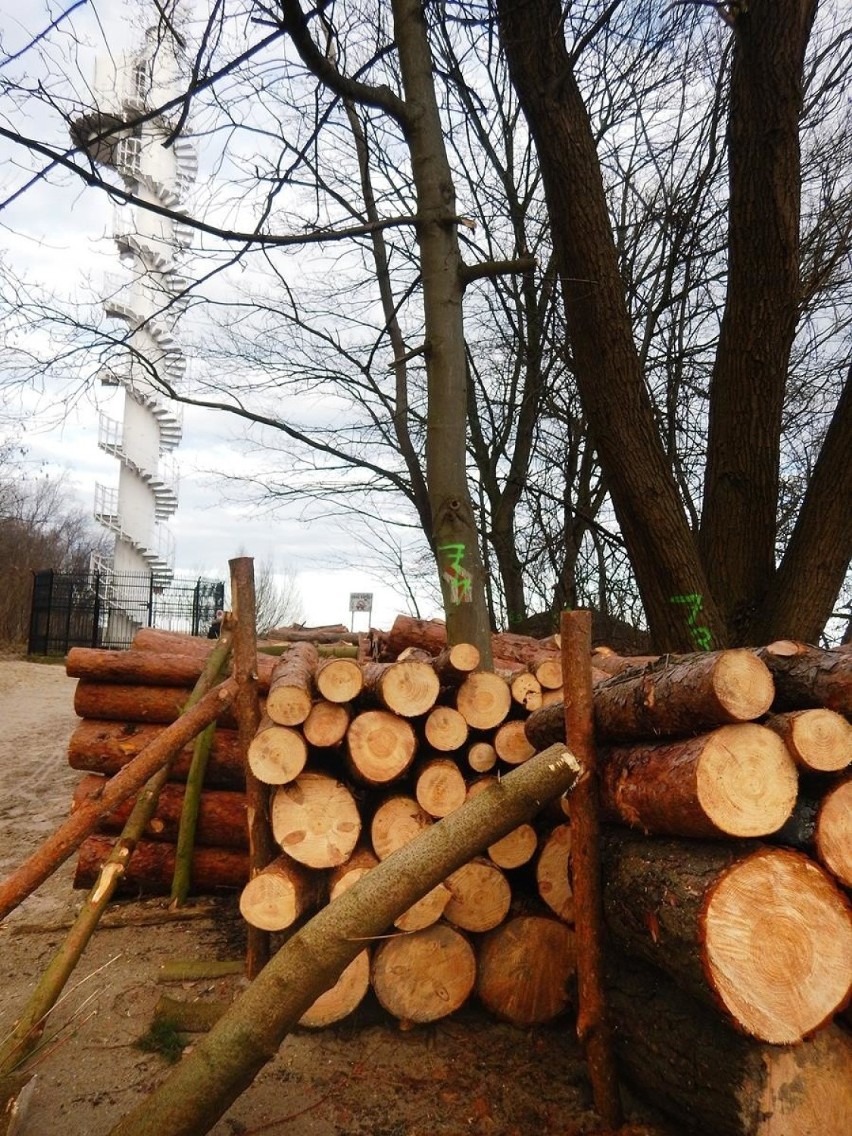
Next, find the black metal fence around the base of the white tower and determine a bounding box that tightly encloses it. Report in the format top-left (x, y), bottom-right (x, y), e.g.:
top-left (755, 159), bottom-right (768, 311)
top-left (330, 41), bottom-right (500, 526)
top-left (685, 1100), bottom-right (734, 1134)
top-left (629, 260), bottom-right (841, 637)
top-left (27, 569), bottom-right (225, 654)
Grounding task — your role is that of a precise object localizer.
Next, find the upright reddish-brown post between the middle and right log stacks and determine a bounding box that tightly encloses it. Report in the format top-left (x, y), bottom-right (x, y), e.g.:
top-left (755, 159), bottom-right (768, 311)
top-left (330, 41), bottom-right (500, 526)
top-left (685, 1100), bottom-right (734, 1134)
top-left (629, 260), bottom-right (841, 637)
top-left (560, 611), bottom-right (623, 1128)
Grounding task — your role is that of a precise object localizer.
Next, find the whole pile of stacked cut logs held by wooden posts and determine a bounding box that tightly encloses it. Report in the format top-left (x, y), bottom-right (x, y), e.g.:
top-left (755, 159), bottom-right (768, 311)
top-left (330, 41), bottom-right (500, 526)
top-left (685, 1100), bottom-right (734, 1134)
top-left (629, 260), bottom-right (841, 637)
top-left (68, 618), bottom-right (852, 1136)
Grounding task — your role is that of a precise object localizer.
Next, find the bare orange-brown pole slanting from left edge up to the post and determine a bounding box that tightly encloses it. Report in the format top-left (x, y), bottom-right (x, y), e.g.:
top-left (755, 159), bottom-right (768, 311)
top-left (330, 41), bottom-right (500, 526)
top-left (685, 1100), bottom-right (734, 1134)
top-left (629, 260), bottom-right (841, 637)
top-left (0, 678), bottom-right (236, 919)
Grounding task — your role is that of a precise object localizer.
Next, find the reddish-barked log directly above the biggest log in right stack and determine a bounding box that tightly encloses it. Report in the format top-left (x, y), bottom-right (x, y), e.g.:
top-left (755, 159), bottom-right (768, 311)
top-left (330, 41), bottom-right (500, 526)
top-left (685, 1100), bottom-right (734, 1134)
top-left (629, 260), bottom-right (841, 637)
top-left (600, 722), bottom-right (799, 837)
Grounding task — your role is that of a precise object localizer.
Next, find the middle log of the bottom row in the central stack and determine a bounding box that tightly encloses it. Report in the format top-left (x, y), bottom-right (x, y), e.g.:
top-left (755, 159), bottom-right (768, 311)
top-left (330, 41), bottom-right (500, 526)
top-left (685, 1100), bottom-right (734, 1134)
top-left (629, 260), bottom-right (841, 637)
top-left (370, 924), bottom-right (476, 1024)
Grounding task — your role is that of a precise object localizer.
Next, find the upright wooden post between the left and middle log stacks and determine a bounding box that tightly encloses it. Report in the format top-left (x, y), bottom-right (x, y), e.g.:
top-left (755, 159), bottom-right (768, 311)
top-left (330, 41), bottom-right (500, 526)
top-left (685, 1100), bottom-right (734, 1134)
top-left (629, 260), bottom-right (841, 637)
top-left (228, 557), bottom-right (278, 978)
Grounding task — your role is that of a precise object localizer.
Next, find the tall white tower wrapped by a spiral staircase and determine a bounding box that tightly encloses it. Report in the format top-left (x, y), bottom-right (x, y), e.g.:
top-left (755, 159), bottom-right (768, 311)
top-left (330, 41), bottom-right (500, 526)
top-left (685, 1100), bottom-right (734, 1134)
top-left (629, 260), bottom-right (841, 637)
top-left (72, 15), bottom-right (198, 595)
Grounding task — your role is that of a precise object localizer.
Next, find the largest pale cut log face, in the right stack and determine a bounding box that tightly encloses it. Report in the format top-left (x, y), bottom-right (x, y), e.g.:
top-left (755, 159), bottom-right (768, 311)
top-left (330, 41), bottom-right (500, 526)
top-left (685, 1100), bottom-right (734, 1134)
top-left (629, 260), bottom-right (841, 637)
top-left (704, 849), bottom-right (852, 1045)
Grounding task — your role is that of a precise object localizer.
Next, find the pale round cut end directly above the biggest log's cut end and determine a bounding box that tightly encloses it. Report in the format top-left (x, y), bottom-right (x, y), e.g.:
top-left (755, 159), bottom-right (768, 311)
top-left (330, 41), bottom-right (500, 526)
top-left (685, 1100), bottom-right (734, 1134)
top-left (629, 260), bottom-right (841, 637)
top-left (696, 724), bottom-right (799, 837)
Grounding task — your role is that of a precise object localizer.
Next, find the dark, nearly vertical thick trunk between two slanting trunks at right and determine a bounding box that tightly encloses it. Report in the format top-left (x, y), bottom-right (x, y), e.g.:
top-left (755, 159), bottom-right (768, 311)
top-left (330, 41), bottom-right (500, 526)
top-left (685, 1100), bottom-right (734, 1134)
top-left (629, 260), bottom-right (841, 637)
top-left (700, 0), bottom-right (818, 644)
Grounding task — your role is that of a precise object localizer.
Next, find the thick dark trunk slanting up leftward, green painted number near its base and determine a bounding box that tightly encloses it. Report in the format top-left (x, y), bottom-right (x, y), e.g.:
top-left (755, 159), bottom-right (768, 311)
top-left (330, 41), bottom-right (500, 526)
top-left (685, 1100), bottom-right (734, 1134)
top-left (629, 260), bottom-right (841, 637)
top-left (496, 0), bottom-right (727, 651)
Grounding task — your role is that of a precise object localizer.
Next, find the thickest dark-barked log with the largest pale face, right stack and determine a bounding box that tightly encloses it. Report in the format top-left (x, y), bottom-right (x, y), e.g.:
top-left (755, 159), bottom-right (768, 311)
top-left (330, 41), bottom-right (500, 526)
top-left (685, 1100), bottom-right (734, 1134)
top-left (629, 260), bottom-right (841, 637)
top-left (603, 838), bottom-right (852, 1045)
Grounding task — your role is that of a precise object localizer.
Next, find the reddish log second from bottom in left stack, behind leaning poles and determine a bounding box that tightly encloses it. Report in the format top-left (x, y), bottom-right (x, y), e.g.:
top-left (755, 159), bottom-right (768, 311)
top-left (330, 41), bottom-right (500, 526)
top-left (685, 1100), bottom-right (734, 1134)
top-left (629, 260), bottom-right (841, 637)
top-left (72, 774), bottom-right (249, 849)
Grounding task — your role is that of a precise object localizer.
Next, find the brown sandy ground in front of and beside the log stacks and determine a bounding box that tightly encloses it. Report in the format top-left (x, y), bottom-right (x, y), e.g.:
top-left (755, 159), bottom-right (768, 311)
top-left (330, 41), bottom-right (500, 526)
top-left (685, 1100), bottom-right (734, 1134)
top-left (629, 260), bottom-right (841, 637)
top-left (0, 660), bottom-right (671, 1136)
